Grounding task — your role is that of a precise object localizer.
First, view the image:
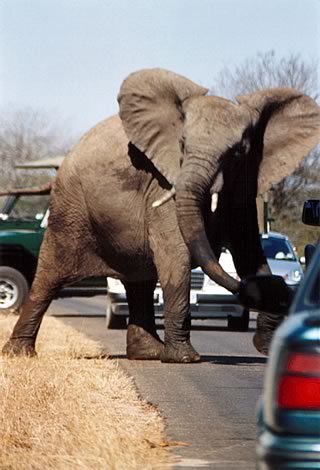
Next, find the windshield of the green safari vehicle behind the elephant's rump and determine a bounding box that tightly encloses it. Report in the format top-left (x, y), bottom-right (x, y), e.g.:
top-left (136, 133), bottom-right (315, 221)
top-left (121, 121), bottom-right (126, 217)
top-left (0, 194), bottom-right (49, 221)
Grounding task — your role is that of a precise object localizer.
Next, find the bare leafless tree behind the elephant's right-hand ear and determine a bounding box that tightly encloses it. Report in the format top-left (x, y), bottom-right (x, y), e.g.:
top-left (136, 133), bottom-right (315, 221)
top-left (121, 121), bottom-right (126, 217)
top-left (210, 51), bottom-right (320, 253)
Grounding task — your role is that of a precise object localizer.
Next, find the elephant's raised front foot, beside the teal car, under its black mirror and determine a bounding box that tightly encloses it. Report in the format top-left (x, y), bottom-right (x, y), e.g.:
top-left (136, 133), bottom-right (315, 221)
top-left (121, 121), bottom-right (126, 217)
top-left (252, 312), bottom-right (284, 356)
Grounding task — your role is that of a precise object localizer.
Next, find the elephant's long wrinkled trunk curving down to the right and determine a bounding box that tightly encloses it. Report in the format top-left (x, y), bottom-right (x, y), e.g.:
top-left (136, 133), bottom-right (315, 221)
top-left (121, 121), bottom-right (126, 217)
top-left (176, 155), bottom-right (239, 293)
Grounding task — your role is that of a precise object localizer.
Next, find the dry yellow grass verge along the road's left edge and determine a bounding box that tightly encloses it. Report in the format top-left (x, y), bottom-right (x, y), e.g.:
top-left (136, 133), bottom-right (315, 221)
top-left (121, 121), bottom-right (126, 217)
top-left (0, 316), bottom-right (172, 470)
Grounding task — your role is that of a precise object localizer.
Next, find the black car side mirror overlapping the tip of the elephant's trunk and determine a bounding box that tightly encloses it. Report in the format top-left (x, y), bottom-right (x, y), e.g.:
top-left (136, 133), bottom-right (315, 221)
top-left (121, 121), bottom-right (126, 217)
top-left (239, 274), bottom-right (293, 314)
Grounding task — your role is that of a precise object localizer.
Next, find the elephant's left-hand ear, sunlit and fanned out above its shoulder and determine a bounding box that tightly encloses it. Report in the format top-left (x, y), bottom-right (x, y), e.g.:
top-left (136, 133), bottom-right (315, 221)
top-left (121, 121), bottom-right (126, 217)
top-left (118, 69), bottom-right (208, 184)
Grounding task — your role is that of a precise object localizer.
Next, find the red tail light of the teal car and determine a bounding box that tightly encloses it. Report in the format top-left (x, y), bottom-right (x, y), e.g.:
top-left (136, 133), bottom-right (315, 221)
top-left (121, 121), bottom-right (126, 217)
top-left (277, 353), bottom-right (320, 410)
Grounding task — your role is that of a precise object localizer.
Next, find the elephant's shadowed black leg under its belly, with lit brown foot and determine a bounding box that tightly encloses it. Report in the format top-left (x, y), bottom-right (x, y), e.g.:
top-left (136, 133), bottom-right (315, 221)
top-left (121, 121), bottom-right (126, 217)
top-left (125, 281), bottom-right (163, 360)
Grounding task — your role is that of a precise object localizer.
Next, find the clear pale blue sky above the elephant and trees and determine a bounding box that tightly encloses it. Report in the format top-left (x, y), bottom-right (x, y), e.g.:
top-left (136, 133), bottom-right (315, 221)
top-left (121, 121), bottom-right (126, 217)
top-left (0, 0), bottom-right (320, 135)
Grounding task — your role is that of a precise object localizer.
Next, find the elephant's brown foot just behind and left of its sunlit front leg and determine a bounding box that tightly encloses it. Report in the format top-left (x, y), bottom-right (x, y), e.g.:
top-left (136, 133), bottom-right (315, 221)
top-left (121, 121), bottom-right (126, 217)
top-left (127, 324), bottom-right (164, 360)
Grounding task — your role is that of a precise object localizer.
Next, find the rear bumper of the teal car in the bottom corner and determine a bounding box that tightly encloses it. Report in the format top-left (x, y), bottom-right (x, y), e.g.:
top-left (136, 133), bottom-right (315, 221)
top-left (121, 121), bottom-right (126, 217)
top-left (257, 430), bottom-right (320, 470)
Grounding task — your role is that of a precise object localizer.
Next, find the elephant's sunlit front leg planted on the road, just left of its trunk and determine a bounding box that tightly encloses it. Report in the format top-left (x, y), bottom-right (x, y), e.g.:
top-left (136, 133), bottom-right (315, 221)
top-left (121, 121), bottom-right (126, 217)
top-left (149, 213), bottom-right (200, 363)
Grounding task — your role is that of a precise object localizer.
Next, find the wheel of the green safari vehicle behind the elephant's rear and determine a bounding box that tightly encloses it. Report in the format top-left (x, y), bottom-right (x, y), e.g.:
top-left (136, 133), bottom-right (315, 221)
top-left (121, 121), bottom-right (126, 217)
top-left (0, 266), bottom-right (29, 313)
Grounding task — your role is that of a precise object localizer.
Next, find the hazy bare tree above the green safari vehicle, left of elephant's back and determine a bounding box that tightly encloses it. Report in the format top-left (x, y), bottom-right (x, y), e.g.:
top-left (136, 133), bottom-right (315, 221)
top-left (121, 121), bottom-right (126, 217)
top-left (0, 108), bottom-right (72, 186)
